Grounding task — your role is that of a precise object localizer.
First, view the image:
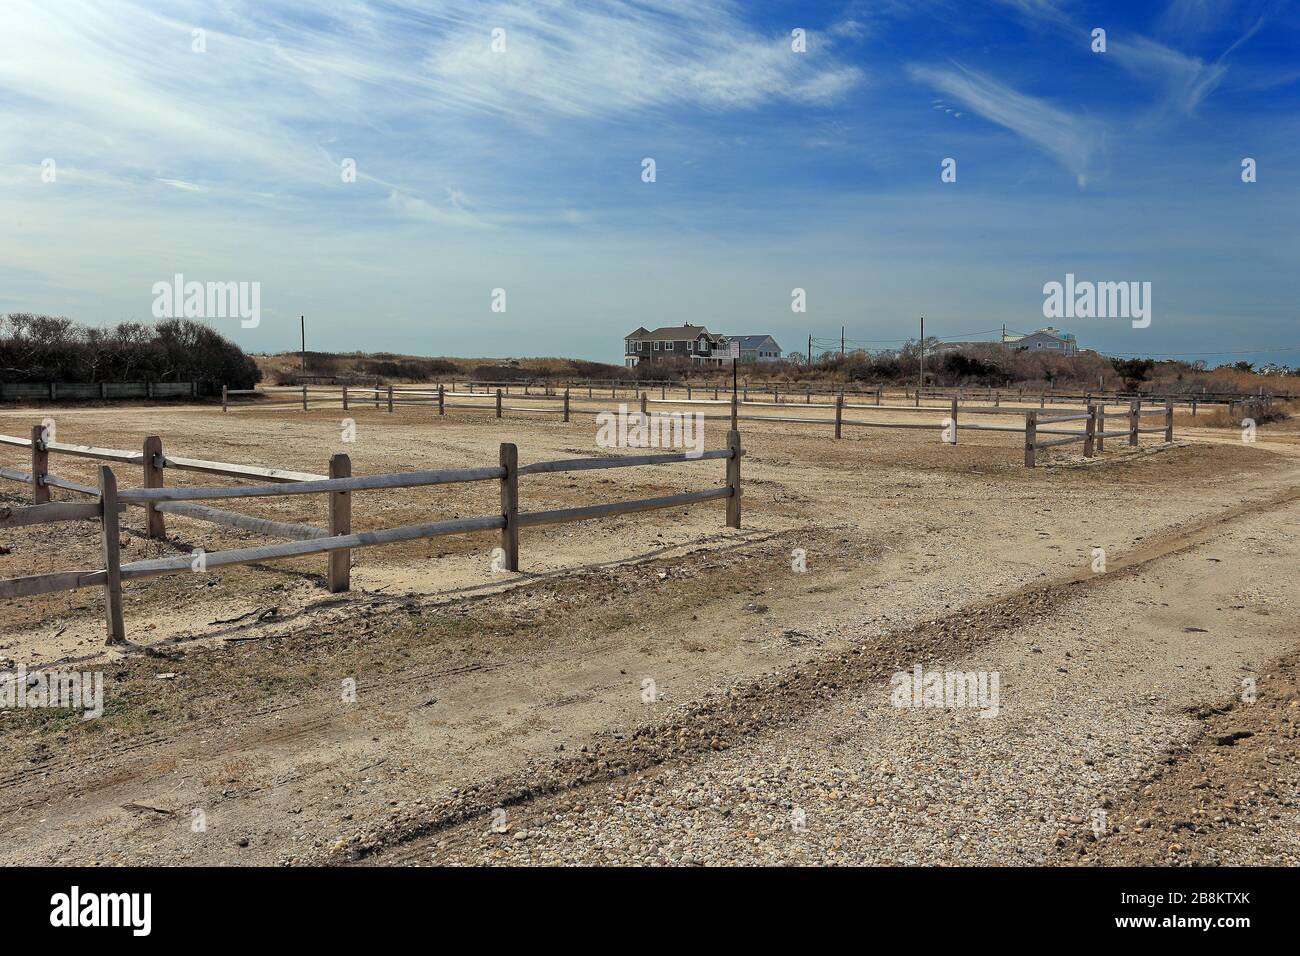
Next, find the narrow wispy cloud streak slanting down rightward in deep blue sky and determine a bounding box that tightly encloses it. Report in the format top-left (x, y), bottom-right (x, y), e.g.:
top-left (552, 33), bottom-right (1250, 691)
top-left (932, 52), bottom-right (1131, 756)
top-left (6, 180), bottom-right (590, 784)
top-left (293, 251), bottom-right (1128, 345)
top-left (910, 65), bottom-right (1102, 186)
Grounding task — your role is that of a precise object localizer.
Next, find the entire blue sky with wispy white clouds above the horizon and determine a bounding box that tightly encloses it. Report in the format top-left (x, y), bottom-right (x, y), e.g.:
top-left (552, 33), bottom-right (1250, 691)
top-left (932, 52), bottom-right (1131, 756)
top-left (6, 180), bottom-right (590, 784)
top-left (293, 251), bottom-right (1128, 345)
top-left (0, 0), bottom-right (1300, 364)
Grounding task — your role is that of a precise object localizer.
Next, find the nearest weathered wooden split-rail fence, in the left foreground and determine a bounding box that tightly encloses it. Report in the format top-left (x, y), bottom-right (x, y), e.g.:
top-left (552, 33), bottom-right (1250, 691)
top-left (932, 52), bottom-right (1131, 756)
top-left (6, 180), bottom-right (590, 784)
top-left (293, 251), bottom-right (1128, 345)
top-left (0, 427), bottom-right (744, 644)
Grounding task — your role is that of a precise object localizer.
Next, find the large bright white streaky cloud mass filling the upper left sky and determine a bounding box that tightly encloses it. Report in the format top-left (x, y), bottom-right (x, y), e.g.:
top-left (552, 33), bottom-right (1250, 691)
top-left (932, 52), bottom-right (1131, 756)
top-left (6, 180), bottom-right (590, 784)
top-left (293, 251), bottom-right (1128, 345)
top-left (0, 0), bottom-right (863, 212)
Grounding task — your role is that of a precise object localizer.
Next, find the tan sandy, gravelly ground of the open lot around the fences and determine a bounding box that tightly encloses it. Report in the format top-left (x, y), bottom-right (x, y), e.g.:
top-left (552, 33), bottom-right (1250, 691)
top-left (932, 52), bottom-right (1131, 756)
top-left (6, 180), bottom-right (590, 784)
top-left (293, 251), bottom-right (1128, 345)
top-left (0, 390), bottom-right (1300, 864)
